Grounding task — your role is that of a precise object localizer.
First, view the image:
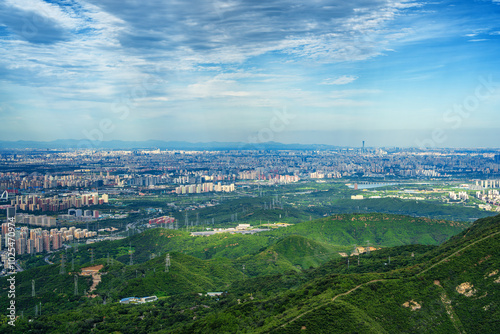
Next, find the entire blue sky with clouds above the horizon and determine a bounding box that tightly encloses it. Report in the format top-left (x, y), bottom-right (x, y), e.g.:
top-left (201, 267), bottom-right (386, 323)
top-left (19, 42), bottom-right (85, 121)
top-left (0, 0), bottom-right (500, 147)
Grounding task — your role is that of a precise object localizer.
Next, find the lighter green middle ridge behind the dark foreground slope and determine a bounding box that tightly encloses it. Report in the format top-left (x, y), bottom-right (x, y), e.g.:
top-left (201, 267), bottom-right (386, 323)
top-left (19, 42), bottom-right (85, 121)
top-left (72, 214), bottom-right (470, 267)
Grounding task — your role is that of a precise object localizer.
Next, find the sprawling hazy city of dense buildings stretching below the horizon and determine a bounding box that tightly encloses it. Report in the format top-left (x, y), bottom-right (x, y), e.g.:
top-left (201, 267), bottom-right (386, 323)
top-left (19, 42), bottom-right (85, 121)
top-left (0, 147), bottom-right (500, 198)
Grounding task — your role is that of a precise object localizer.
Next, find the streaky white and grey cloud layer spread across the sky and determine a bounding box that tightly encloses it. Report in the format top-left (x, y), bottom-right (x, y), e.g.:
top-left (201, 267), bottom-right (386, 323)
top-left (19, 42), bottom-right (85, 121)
top-left (0, 0), bottom-right (500, 146)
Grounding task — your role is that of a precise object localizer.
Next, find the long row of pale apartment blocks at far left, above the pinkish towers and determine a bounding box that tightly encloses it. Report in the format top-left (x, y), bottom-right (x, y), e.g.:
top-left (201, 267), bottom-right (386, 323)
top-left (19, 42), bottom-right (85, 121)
top-left (10, 193), bottom-right (109, 211)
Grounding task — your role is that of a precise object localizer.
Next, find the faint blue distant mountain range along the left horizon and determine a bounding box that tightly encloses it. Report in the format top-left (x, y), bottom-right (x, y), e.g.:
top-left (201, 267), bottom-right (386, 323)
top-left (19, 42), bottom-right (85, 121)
top-left (0, 139), bottom-right (338, 151)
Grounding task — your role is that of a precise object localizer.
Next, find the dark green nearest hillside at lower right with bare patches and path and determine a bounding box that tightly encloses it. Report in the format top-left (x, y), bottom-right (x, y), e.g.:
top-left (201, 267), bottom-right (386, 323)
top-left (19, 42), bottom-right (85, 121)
top-left (185, 216), bottom-right (500, 333)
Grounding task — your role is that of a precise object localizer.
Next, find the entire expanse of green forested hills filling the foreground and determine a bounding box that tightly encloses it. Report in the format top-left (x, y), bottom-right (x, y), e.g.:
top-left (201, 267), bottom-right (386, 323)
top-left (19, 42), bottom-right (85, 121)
top-left (0, 215), bottom-right (500, 333)
